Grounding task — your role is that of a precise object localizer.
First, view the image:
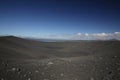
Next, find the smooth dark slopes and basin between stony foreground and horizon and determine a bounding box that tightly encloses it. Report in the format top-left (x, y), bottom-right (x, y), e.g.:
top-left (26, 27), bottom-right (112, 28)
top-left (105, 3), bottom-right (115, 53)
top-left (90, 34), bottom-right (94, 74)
top-left (0, 36), bottom-right (120, 59)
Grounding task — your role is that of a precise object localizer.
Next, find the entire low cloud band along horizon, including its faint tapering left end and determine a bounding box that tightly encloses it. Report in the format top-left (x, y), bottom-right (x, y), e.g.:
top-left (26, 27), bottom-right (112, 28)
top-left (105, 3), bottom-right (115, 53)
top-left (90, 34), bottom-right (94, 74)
top-left (42, 32), bottom-right (120, 40)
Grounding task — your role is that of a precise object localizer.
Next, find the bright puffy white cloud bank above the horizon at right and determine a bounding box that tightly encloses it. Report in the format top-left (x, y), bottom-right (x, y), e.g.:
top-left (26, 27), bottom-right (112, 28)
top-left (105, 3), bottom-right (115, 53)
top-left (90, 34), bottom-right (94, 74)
top-left (72, 32), bottom-right (120, 40)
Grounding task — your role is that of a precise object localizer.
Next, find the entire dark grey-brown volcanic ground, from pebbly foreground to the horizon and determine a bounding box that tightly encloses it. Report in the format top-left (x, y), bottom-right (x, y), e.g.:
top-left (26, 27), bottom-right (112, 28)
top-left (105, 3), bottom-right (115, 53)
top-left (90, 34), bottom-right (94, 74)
top-left (0, 36), bottom-right (120, 80)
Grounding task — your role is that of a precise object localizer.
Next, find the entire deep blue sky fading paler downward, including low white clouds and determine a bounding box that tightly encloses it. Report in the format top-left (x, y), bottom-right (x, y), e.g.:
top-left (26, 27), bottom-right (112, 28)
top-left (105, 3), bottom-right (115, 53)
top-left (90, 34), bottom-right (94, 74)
top-left (0, 0), bottom-right (120, 39)
